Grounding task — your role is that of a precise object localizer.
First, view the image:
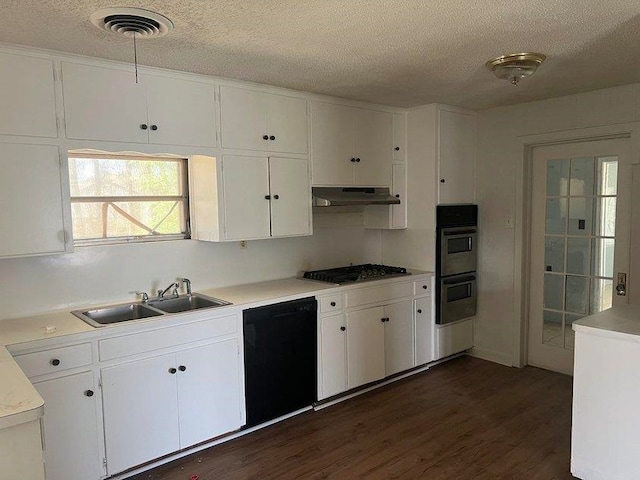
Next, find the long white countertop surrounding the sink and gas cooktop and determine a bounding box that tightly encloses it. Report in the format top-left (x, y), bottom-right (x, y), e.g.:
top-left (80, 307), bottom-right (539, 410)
top-left (0, 271), bottom-right (430, 428)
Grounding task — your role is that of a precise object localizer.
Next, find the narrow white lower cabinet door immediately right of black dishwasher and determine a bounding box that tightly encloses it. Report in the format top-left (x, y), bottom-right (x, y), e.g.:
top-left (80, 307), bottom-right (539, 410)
top-left (320, 315), bottom-right (347, 399)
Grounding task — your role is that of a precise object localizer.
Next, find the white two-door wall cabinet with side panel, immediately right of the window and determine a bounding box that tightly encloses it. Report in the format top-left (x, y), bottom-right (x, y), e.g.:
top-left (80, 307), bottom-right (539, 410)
top-left (189, 155), bottom-right (311, 241)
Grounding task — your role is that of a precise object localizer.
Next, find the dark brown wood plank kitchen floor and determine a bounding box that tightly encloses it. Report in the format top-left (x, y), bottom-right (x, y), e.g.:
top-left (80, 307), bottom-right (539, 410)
top-left (125, 357), bottom-right (574, 480)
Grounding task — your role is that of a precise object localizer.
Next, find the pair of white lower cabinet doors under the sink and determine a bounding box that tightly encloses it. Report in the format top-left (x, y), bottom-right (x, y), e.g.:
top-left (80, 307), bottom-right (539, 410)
top-left (102, 339), bottom-right (242, 475)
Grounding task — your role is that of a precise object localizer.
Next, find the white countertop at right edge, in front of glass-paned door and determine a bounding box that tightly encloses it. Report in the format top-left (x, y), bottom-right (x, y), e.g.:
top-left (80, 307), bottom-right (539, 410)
top-left (573, 305), bottom-right (640, 343)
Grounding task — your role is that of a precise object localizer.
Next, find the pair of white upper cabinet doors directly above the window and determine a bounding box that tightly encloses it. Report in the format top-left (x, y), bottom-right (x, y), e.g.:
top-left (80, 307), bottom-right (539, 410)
top-left (62, 62), bottom-right (216, 147)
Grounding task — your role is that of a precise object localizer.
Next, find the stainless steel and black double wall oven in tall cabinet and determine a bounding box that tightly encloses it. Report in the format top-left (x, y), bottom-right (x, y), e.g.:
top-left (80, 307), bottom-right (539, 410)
top-left (436, 205), bottom-right (478, 325)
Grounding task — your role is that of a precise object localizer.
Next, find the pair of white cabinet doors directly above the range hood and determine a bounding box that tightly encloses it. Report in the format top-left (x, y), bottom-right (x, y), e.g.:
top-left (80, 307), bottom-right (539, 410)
top-left (311, 102), bottom-right (393, 186)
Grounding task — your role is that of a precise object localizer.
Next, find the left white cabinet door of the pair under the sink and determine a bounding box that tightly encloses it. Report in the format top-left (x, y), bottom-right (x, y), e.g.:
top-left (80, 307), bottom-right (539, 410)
top-left (102, 354), bottom-right (180, 475)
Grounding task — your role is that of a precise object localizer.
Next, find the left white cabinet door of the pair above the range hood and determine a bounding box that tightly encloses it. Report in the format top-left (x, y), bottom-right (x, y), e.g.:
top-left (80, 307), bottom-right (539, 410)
top-left (311, 102), bottom-right (355, 186)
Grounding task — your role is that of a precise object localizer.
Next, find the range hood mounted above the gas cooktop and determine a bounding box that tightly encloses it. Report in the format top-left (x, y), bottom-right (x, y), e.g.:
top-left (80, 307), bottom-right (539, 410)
top-left (311, 187), bottom-right (400, 207)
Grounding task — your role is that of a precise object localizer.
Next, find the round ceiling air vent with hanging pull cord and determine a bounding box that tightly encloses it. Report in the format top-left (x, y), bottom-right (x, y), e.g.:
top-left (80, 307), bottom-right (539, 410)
top-left (89, 7), bottom-right (173, 39)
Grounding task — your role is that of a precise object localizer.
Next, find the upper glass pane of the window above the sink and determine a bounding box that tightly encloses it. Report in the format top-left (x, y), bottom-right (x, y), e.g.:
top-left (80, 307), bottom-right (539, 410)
top-left (69, 157), bottom-right (182, 197)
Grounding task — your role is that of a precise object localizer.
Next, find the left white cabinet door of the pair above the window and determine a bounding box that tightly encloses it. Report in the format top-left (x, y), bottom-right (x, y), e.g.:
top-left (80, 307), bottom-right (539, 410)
top-left (62, 62), bottom-right (149, 143)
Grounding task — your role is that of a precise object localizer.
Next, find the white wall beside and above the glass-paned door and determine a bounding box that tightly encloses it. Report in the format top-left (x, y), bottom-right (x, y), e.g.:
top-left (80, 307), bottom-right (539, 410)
top-left (475, 82), bottom-right (640, 365)
